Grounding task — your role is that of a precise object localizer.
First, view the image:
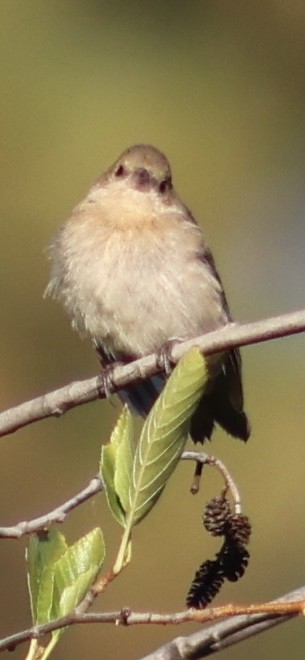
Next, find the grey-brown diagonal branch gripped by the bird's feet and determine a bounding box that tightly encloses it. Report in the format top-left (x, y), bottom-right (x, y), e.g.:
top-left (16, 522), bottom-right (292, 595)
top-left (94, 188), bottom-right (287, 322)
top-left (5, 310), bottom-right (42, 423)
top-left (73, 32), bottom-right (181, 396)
top-left (0, 310), bottom-right (305, 436)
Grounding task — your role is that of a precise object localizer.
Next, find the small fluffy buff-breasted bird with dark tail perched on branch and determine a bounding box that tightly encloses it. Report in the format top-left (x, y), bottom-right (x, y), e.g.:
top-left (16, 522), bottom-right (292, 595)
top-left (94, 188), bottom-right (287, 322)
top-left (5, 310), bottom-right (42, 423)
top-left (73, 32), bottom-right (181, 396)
top-left (46, 144), bottom-right (250, 442)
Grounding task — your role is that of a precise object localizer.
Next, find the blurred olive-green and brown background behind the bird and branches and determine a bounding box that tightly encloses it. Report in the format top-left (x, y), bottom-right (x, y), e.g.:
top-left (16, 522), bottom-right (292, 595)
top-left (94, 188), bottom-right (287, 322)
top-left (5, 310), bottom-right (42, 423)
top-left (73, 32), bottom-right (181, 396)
top-left (0, 0), bottom-right (305, 660)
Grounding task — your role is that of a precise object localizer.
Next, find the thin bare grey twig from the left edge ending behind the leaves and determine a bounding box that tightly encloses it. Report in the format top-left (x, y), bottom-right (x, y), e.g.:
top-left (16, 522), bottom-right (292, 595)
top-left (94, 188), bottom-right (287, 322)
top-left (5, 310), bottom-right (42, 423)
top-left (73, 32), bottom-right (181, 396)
top-left (0, 477), bottom-right (104, 539)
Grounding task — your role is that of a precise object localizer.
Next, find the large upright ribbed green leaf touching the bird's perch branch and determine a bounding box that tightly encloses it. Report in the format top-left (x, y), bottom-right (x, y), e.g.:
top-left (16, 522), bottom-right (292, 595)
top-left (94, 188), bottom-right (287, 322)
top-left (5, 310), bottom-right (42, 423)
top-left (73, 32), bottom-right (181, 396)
top-left (127, 348), bottom-right (208, 528)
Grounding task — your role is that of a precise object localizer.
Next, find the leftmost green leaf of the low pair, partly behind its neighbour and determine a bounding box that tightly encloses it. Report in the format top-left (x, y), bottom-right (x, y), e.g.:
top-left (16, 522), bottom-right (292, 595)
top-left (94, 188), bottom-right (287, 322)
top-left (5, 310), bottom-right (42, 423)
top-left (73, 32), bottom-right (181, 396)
top-left (26, 527), bottom-right (67, 624)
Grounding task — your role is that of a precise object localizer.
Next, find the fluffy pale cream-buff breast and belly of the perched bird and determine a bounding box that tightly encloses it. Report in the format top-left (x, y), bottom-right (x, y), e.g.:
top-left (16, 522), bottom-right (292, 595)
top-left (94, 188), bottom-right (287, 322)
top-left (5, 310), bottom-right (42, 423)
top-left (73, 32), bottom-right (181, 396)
top-left (48, 201), bottom-right (227, 356)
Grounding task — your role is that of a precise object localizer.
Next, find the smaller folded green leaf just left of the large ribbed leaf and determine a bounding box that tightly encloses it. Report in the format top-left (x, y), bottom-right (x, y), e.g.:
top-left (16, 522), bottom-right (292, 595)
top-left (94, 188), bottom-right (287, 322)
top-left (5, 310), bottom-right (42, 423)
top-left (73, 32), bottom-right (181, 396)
top-left (100, 406), bottom-right (134, 527)
